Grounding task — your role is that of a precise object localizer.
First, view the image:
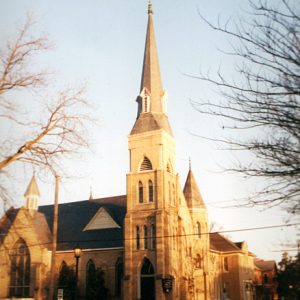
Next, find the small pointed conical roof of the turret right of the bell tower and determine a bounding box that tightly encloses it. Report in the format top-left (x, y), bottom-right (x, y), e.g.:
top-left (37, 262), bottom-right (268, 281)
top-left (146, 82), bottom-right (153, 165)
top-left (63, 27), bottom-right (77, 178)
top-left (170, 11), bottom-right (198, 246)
top-left (183, 168), bottom-right (205, 208)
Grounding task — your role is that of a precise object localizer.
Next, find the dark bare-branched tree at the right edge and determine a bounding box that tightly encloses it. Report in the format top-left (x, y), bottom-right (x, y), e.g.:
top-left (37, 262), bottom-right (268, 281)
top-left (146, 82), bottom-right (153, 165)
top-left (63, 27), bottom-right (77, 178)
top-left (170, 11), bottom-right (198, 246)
top-left (192, 0), bottom-right (300, 214)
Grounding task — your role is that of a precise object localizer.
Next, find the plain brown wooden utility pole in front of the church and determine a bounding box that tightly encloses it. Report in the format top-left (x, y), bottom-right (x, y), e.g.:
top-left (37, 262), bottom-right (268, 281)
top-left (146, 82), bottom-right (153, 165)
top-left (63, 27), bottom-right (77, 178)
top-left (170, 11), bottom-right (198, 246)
top-left (49, 175), bottom-right (59, 300)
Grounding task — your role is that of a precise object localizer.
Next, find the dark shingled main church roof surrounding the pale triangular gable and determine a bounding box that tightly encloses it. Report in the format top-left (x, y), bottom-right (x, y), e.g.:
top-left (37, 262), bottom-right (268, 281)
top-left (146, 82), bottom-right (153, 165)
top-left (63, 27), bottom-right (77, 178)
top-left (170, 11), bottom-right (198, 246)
top-left (39, 196), bottom-right (126, 250)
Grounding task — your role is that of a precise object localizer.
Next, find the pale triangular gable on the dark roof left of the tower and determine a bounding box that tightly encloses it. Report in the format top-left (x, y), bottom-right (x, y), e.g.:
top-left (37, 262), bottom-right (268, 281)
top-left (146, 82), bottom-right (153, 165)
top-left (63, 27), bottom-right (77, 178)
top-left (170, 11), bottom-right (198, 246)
top-left (83, 207), bottom-right (120, 231)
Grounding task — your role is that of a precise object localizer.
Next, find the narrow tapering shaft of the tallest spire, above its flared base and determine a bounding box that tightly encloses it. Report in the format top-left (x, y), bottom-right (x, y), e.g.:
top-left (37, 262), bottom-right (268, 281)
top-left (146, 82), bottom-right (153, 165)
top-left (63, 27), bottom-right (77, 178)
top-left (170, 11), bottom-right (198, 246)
top-left (140, 1), bottom-right (164, 113)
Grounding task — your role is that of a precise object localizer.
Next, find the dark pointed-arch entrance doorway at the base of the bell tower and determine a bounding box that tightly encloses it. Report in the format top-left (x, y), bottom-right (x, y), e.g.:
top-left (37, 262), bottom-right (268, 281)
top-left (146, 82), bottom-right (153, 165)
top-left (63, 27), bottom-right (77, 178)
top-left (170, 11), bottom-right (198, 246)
top-left (140, 258), bottom-right (155, 300)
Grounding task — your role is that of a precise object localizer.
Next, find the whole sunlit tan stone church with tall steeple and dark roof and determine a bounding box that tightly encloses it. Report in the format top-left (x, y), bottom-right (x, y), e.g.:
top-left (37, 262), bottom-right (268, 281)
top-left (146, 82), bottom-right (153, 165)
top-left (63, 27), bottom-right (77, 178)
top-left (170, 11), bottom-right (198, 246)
top-left (0, 3), bottom-right (262, 300)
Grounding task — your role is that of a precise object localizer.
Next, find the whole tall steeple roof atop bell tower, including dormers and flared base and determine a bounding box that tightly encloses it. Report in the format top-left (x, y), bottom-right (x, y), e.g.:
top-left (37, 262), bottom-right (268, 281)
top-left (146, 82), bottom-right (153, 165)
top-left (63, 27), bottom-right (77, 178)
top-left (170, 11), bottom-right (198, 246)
top-left (131, 1), bottom-right (172, 135)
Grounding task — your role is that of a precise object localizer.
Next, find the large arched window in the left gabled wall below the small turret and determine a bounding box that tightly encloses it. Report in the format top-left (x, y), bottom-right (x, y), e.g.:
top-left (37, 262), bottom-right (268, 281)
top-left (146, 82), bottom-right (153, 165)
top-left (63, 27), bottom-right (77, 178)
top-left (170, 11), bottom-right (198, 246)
top-left (9, 239), bottom-right (30, 298)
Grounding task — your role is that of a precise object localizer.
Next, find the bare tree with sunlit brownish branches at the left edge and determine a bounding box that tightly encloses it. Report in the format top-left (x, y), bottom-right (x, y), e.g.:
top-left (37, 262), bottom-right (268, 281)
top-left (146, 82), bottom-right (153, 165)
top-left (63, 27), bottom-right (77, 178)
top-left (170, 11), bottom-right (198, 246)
top-left (0, 17), bottom-right (91, 210)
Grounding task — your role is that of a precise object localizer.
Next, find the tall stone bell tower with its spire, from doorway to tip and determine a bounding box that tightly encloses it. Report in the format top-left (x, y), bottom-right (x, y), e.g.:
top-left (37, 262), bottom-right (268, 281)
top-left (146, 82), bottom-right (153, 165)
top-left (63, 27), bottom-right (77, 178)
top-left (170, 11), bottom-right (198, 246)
top-left (124, 2), bottom-right (178, 299)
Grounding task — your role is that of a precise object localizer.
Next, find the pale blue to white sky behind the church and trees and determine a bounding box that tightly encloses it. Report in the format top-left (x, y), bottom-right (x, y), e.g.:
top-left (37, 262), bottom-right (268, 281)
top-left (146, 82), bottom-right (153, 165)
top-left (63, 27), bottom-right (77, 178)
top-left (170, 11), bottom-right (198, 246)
top-left (0, 0), bottom-right (299, 260)
